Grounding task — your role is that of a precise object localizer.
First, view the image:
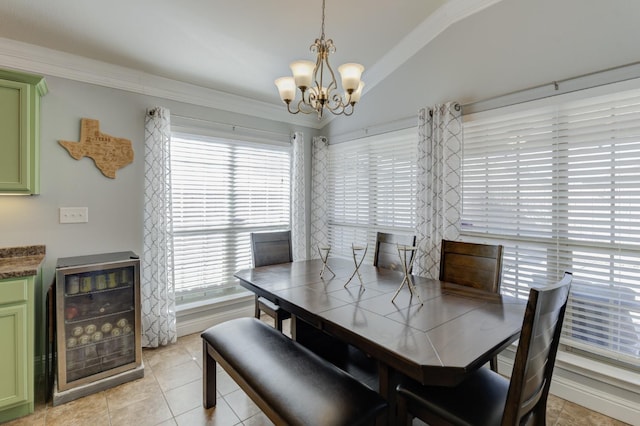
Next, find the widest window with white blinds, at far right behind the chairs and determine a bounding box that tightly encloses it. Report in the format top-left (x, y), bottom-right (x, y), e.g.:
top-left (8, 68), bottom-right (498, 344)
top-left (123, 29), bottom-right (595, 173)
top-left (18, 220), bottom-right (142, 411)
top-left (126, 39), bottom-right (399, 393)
top-left (462, 83), bottom-right (640, 365)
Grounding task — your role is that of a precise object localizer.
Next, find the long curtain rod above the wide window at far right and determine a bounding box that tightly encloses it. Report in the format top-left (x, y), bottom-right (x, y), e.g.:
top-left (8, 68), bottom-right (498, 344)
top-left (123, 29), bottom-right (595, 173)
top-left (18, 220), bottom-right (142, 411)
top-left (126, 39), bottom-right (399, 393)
top-left (462, 62), bottom-right (640, 115)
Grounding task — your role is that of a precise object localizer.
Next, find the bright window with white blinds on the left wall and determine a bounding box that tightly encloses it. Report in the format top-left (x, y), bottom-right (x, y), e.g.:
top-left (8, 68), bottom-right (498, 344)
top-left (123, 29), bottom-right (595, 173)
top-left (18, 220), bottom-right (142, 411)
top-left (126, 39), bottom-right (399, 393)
top-left (171, 133), bottom-right (291, 302)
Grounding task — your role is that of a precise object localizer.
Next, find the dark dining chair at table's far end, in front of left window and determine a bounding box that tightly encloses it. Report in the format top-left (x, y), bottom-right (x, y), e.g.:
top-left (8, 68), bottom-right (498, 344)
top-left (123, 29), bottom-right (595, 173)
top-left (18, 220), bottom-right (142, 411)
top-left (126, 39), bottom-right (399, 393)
top-left (251, 231), bottom-right (293, 331)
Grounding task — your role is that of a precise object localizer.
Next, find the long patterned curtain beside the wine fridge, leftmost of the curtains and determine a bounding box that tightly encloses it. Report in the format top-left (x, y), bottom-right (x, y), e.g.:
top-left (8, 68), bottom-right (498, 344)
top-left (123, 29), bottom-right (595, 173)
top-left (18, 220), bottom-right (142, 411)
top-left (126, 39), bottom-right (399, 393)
top-left (141, 107), bottom-right (177, 347)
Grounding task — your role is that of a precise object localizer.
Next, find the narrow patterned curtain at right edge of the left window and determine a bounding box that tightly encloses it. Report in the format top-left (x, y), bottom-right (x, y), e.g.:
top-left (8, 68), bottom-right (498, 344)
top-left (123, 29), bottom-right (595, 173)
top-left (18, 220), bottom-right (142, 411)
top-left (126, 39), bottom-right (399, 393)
top-left (291, 132), bottom-right (307, 261)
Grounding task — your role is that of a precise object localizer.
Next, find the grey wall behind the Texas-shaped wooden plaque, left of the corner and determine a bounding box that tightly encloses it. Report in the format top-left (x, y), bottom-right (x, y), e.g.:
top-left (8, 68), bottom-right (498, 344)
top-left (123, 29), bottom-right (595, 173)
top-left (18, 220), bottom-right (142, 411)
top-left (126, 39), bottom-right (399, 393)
top-left (0, 75), bottom-right (317, 384)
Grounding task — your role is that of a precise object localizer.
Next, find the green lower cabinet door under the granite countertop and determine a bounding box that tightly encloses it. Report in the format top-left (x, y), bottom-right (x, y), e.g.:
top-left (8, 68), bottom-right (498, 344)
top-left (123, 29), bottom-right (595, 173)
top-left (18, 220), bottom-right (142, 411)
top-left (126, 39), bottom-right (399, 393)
top-left (0, 303), bottom-right (29, 408)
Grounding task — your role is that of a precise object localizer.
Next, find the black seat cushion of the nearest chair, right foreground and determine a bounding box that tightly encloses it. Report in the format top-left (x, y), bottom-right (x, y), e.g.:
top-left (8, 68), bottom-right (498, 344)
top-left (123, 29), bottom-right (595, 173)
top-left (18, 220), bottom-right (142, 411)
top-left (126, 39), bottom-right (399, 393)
top-left (397, 368), bottom-right (509, 426)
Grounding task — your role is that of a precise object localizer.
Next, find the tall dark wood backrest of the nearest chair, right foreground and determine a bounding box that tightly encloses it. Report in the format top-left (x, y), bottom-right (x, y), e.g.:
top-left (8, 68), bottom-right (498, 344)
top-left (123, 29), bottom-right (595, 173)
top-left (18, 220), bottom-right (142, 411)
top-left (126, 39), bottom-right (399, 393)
top-left (502, 272), bottom-right (573, 425)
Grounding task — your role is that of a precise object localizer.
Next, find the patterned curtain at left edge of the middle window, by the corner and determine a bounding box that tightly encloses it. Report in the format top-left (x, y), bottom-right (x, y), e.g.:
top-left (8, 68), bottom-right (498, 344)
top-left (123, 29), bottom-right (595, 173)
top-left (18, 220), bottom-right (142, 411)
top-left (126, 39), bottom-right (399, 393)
top-left (310, 136), bottom-right (329, 258)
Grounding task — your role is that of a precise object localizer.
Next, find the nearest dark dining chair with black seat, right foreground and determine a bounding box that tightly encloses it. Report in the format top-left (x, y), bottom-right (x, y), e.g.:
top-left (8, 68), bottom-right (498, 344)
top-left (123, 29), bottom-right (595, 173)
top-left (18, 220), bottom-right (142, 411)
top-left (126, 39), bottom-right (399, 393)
top-left (396, 272), bottom-right (573, 426)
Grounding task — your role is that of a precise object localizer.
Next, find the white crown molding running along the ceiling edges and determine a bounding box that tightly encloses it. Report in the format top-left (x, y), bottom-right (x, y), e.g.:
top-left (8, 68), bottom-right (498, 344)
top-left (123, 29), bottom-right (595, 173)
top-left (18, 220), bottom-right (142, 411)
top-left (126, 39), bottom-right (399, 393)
top-left (0, 0), bottom-right (501, 129)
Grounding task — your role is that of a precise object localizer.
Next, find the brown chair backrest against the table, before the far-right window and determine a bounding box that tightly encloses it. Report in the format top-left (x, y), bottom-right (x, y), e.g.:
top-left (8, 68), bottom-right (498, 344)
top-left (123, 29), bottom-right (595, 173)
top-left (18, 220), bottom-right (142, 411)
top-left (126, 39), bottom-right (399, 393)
top-left (440, 240), bottom-right (503, 293)
